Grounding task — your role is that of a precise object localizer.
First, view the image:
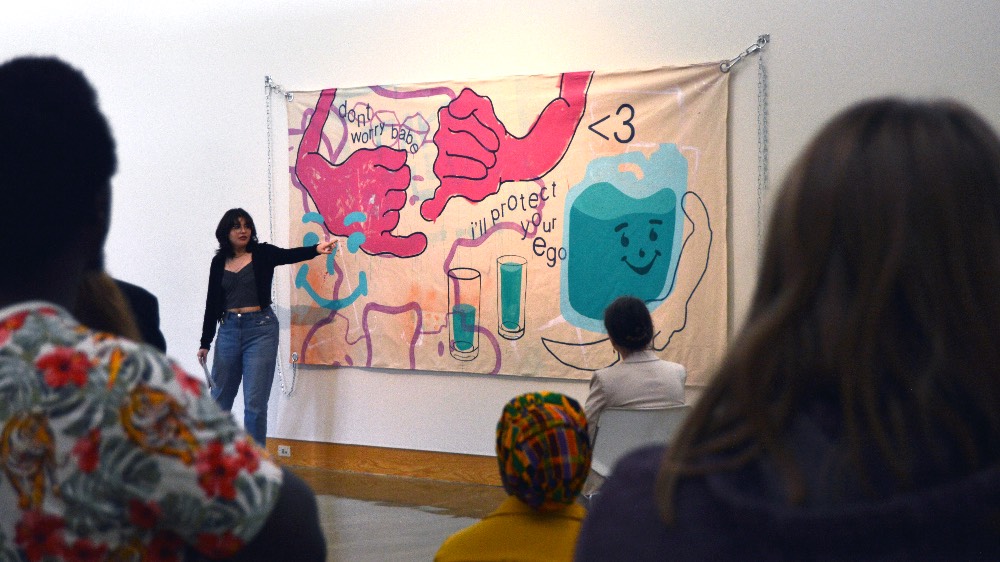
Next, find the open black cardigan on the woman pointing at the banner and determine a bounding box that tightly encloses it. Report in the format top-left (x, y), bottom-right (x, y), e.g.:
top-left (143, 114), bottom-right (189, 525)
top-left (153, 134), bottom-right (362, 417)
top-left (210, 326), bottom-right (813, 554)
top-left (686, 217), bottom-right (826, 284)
top-left (201, 243), bottom-right (319, 349)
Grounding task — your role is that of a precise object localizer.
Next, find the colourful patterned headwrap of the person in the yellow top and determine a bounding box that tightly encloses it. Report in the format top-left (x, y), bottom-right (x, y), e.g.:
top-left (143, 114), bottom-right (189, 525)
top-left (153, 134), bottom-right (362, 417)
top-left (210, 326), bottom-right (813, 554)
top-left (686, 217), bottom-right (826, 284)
top-left (497, 392), bottom-right (591, 512)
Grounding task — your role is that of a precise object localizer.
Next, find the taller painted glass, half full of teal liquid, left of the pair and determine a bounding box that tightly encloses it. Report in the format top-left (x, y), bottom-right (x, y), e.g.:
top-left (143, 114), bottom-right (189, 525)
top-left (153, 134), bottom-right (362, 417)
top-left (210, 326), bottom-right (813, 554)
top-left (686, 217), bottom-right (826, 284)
top-left (448, 267), bottom-right (482, 361)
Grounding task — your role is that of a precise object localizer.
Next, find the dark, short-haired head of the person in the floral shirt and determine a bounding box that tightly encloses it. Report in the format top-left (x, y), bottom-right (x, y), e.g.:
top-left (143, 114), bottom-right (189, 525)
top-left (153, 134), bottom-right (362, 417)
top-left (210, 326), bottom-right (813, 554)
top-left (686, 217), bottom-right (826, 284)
top-left (0, 57), bottom-right (117, 294)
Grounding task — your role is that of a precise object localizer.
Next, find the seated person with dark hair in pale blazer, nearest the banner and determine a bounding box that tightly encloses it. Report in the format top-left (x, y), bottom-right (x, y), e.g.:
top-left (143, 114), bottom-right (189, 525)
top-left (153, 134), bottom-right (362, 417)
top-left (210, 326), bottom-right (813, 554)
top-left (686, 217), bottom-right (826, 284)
top-left (584, 296), bottom-right (687, 442)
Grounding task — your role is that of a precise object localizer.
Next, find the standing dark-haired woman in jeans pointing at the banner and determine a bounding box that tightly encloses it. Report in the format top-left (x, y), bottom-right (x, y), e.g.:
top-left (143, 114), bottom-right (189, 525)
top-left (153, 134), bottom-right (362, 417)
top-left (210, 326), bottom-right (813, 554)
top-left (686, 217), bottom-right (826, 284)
top-left (198, 209), bottom-right (337, 447)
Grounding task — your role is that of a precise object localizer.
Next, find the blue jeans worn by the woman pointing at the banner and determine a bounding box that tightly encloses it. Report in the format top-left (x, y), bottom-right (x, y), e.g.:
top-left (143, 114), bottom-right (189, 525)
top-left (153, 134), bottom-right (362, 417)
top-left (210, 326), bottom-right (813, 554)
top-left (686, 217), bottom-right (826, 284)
top-left (212, 307), bottom-right (278, 447)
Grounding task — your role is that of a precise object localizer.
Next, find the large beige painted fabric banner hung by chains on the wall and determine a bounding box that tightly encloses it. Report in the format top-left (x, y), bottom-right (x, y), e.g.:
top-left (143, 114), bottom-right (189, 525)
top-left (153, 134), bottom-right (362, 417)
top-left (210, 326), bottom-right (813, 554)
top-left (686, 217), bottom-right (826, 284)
top-left (287, 63), bottom-right (728, 384)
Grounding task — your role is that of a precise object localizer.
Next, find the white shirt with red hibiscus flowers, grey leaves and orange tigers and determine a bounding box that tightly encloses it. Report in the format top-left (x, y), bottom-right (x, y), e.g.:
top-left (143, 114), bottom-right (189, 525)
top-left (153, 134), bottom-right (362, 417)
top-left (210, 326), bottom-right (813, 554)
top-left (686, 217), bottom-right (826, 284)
top-left (0, 302), bottom-right (281, 562)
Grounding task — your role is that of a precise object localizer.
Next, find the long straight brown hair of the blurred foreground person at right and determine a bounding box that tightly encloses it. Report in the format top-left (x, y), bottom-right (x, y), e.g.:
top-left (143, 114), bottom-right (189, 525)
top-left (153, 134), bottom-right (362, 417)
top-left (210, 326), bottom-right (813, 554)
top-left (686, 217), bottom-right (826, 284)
top-left (657, 99), bottom-right (1000, 522)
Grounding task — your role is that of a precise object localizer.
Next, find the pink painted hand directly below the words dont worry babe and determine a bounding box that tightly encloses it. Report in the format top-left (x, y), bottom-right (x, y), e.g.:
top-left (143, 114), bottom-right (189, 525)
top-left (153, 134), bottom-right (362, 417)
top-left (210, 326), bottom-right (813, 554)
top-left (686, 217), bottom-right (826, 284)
top-left (295, 89), bottom-right (427, 258)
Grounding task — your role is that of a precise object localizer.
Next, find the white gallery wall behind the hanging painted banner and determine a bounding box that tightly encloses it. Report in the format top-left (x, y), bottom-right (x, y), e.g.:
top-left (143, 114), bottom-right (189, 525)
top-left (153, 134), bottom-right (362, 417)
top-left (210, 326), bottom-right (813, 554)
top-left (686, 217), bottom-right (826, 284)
top-left (0, 0), bottom-right (1000, 455)
